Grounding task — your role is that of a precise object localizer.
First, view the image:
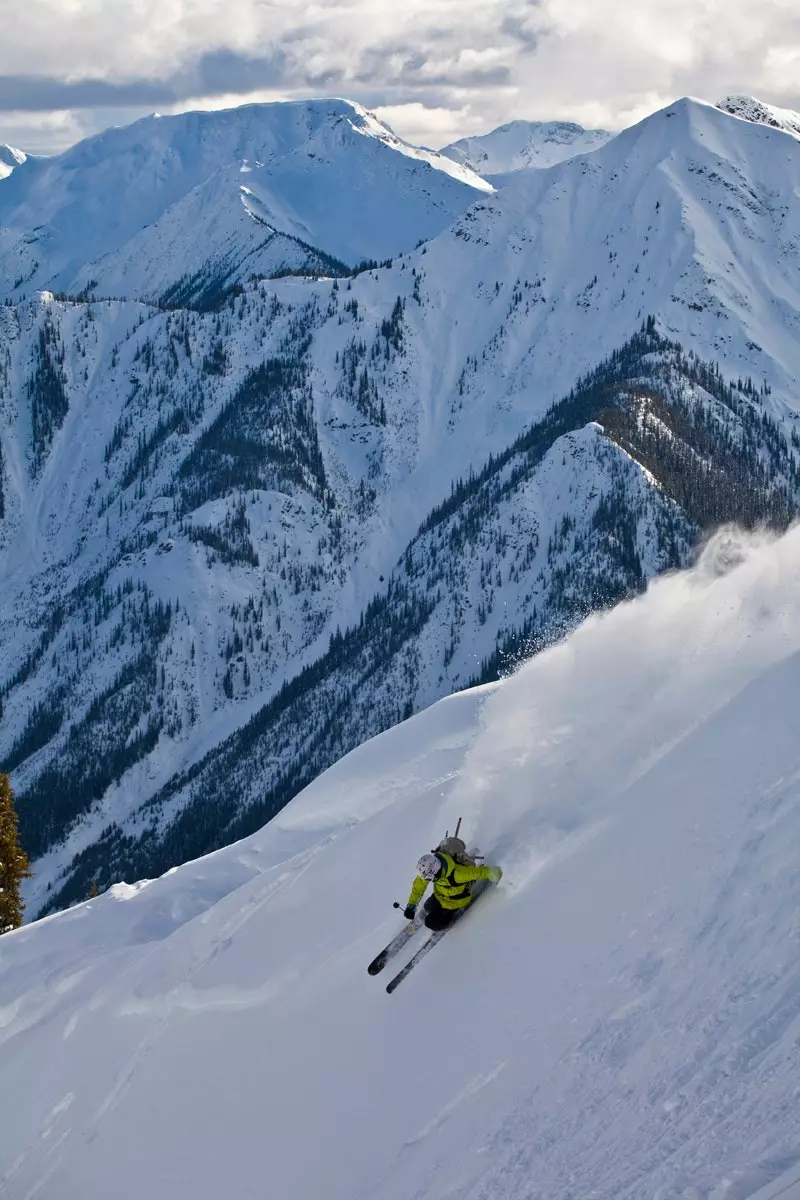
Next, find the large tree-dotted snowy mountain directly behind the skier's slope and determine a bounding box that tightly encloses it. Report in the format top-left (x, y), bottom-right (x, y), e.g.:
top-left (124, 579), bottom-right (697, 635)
top-left (0, 101), bottom-right (800, 911)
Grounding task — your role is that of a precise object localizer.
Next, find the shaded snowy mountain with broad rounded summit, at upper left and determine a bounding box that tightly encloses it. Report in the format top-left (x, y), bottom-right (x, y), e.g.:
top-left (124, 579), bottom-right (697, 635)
top-left (0, 100), bottom-right (491, 304)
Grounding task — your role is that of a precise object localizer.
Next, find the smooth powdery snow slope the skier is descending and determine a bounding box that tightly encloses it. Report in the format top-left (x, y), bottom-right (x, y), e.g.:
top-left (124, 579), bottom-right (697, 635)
top-left (0, 530), bottom-right (800, 1200)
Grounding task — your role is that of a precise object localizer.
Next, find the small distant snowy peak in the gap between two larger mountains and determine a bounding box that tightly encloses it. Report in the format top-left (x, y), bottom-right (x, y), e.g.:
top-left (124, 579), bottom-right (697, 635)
top-left (439, 121), bottom-right (613, 181)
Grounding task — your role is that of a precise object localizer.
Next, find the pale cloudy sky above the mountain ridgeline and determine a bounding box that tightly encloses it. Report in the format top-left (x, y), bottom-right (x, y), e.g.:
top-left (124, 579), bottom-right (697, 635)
top-left (0, 0), bottom-right (800, 152)
